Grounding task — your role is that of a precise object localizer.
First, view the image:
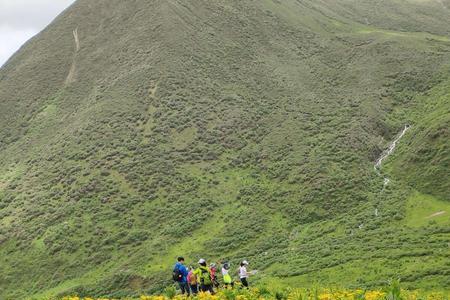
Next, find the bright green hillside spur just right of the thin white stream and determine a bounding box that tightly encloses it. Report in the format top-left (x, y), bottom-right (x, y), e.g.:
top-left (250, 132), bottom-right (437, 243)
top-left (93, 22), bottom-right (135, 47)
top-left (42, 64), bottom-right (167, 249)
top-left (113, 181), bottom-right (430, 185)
top-left (386, 74), bottom-right (450, 202)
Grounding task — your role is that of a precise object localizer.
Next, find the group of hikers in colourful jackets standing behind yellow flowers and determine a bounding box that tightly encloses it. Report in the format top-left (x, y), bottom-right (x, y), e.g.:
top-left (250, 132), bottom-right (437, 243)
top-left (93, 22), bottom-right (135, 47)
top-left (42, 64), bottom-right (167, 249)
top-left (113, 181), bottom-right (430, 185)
top-left (173, 256), bottom-right (255, 296)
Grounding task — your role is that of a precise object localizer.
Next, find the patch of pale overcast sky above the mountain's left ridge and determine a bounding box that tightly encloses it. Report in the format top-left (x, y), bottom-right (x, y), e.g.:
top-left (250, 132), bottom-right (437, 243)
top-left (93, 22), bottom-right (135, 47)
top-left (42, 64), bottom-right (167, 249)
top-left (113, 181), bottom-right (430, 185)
top-left (0, 0), bottom-right (75, 66)
